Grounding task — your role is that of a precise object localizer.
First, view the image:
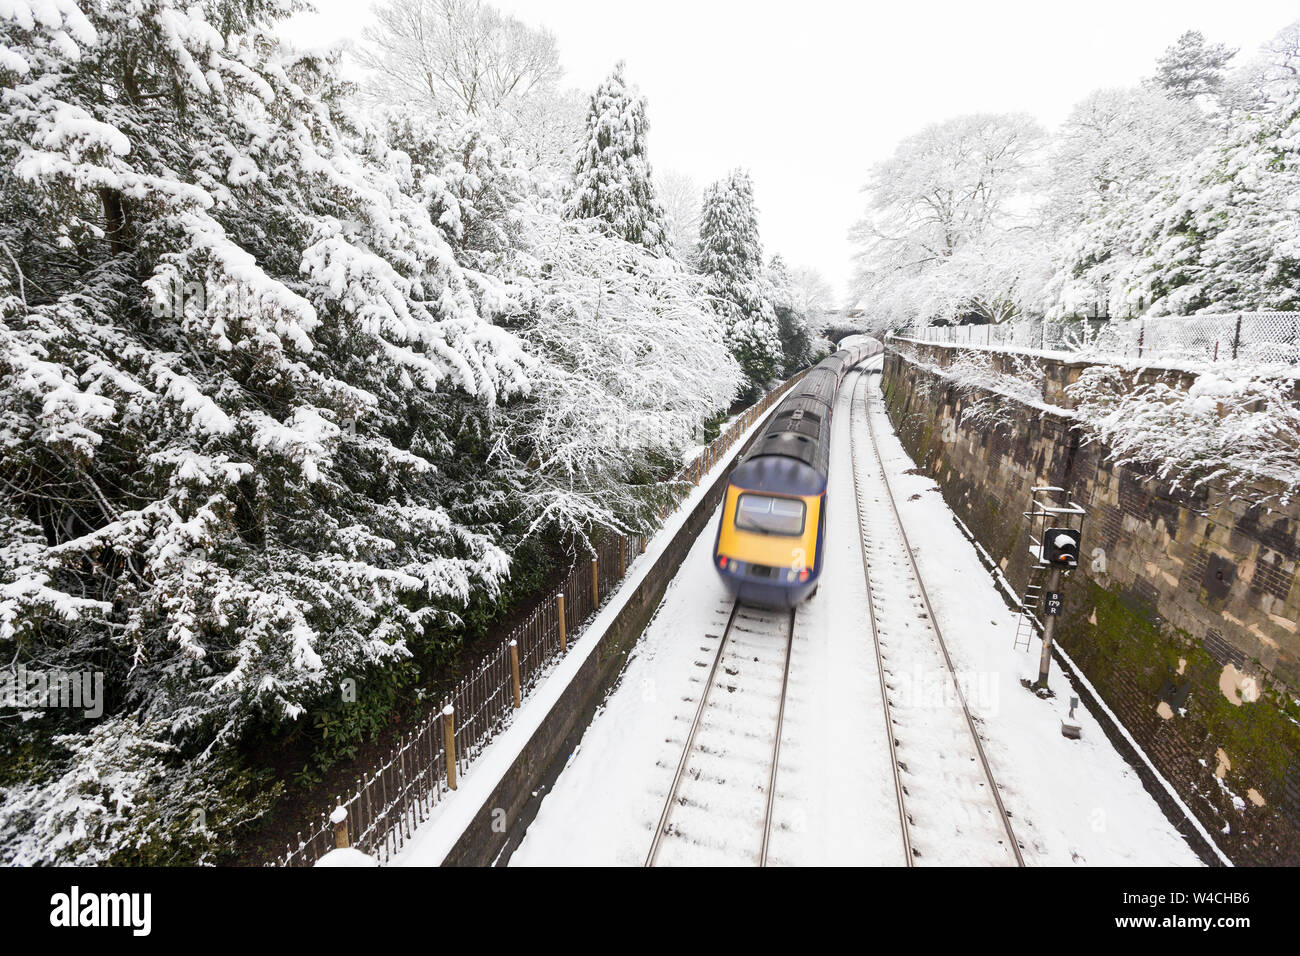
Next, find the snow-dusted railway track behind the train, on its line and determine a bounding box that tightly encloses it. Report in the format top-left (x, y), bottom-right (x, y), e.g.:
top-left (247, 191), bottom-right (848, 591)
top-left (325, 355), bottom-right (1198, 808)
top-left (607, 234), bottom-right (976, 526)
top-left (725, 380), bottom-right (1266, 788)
top-left (645, 601), bottom-right (794, 866)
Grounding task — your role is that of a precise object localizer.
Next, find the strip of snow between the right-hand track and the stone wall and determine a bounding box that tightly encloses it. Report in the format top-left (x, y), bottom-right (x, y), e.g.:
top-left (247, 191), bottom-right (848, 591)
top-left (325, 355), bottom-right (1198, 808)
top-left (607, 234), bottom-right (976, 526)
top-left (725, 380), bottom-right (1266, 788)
top-left (867, 364), bottom-right (1200, 866)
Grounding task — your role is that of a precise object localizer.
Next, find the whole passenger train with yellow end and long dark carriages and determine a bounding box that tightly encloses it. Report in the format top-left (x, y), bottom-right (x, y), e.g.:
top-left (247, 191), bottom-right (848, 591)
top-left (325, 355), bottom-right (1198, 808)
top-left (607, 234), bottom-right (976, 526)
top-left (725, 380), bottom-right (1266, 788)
top-left (714, 336), bottom-right (884, 607)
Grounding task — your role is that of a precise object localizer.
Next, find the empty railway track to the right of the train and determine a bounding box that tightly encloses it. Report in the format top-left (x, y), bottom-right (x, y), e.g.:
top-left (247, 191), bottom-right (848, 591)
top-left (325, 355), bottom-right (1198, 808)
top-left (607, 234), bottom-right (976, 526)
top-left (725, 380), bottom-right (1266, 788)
top-left (849, 373), bottom-right (1024, 866)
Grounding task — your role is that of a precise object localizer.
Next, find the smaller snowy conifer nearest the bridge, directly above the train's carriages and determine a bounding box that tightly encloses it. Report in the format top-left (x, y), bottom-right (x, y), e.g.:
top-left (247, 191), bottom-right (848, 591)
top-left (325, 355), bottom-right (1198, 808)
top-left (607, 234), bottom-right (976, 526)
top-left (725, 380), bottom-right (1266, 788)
top-left (699, 169), bottom-right (784, 395)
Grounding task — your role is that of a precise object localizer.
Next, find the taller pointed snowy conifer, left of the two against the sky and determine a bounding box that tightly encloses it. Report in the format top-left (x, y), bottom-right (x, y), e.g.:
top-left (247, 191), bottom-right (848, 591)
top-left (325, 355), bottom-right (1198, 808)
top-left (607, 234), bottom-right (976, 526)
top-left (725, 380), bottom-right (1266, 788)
top-left (567, 62), bottom-right (670, 255)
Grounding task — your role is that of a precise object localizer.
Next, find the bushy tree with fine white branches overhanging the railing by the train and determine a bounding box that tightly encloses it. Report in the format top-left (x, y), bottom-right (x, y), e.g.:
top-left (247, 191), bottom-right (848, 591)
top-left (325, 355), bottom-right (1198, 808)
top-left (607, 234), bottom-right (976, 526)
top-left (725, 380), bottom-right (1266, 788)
top-left (503, 215), bottom-right (741, 545)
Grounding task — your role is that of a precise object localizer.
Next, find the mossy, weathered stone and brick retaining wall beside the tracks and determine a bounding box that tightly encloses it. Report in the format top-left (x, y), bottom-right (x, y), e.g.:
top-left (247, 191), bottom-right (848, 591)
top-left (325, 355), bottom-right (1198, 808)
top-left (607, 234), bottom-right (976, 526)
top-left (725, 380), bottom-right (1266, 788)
top-left (884, 351), bottom-right (1300, 865)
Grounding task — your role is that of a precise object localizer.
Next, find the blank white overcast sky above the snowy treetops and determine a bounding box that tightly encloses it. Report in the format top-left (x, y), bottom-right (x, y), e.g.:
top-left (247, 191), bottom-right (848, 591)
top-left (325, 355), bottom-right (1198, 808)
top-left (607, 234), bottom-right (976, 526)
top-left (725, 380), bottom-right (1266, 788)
top-left (286, 0), bottom-right (1300, 306)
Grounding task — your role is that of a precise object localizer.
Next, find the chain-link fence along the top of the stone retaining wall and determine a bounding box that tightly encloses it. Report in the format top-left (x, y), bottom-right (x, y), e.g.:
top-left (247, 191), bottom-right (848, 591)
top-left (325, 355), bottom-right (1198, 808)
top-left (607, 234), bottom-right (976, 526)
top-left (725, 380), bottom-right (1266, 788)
top-left (894, 312), bottom-right (1300, 364)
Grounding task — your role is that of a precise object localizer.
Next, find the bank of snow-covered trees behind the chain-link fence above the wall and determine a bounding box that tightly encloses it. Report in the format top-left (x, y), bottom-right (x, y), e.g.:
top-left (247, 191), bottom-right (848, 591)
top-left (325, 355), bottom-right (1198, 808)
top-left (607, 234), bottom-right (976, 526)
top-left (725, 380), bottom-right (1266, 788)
top-left (854, 23), bottom-right (1300, 328)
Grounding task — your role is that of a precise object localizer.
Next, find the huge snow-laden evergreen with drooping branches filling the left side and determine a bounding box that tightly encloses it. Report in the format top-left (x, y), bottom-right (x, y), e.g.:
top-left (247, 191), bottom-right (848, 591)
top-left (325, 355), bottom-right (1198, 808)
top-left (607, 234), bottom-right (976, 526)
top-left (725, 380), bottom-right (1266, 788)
top-left (0, 0), bottom-right (528, 862)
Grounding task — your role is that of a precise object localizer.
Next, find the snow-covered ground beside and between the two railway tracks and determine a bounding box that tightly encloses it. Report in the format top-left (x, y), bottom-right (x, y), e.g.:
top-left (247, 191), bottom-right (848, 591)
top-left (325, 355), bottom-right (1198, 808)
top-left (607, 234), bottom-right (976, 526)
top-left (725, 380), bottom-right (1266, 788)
top-left (511, 358), bottom-right (1199, 865)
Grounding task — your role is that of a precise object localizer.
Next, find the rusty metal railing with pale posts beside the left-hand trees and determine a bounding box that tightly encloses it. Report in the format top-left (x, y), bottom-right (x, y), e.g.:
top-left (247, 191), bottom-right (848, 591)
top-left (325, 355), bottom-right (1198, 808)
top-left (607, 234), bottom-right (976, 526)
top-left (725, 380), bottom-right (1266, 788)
top-left (272, 372), bottom-right (803, 866)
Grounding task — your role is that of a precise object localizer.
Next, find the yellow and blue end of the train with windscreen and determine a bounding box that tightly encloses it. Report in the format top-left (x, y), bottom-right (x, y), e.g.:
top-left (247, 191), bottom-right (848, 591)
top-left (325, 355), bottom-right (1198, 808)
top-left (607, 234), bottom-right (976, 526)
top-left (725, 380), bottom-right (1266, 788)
top-left (714, 442), bottom-right (826, 607)
